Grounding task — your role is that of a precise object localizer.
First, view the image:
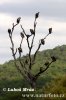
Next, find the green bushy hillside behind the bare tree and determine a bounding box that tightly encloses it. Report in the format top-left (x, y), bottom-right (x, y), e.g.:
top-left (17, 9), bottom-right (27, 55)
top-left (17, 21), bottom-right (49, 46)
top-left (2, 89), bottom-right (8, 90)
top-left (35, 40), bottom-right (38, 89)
top-left (0, 45), bottom-right (66, 100)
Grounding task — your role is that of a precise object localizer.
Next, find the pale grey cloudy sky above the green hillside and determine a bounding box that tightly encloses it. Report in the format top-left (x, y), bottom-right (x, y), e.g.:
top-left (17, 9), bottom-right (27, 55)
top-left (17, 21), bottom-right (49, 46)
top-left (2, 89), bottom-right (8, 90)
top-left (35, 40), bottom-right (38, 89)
top-left (0, 0), bottom-right (66, 64)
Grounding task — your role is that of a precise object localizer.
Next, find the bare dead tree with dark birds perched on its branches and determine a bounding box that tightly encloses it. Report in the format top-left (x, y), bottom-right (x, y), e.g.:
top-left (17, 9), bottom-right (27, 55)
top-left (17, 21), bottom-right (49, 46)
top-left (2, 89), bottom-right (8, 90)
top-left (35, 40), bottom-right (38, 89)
top-left (8, 12), bottom-right (56, 87)
